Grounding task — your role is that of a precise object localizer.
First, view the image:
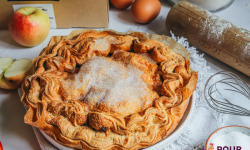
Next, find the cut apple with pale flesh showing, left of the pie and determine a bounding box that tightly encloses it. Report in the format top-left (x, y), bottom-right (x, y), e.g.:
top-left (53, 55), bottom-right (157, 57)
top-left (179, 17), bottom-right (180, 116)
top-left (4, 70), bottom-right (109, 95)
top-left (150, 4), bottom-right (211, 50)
top-left (0, 57), bottom-right (33, 89)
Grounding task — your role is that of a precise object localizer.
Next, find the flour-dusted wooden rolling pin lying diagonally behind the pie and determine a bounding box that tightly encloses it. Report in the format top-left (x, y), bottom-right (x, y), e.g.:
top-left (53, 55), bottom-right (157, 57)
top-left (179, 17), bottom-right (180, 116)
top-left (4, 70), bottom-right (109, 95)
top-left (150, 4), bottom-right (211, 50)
top-left (166, 1), bottom-right (250, 76)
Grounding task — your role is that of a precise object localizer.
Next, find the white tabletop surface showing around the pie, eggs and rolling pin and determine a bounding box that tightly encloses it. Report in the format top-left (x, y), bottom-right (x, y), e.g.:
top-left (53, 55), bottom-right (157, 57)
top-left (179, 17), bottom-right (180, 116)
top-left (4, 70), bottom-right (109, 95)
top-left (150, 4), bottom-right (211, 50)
top-left (0, 0), bottom-right (250, 150)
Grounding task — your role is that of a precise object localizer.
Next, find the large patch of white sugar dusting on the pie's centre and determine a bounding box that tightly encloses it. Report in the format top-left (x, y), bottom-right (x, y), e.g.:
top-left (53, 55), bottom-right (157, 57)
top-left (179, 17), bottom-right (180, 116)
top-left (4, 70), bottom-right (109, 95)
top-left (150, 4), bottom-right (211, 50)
top-left (64, 57), bottom-right (147, 106)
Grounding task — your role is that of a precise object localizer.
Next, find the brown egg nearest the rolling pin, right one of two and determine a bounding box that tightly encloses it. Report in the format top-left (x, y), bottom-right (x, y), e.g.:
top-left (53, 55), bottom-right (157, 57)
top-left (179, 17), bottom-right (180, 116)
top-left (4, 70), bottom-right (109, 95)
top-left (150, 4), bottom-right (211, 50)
top-left (131, 0), bottom-right (161, 23)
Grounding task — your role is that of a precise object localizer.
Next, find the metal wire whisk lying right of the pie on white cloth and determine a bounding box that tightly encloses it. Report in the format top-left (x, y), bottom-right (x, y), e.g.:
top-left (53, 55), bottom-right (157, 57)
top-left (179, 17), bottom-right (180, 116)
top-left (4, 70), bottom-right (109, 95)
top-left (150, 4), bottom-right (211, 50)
top-left (204, 71), bottom-right (250, 116)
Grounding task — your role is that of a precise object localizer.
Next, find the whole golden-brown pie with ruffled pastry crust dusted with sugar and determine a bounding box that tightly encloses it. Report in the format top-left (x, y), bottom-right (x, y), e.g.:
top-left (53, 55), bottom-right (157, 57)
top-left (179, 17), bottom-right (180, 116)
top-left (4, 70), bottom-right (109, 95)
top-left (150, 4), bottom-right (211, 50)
top-left (22, 30), bottom-right (198, 150)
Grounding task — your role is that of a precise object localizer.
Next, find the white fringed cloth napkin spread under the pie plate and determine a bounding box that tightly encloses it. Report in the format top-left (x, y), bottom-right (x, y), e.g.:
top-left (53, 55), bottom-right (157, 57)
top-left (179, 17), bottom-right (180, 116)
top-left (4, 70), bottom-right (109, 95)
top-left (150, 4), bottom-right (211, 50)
top-left (19, 35), bottom-right (250, 150)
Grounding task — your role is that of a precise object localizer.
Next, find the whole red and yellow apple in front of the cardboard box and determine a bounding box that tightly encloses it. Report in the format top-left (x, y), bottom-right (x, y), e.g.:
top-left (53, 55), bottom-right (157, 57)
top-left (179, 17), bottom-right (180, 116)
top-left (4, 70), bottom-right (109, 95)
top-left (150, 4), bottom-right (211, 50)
top-left (9, 7), bottom-right (50, 47)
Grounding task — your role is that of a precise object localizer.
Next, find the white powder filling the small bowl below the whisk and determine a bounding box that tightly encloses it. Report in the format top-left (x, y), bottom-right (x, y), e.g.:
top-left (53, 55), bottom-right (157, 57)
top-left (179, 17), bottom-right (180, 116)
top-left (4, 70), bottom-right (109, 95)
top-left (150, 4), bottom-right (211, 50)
top-left (211, 131), bottom-right (250, 150)
